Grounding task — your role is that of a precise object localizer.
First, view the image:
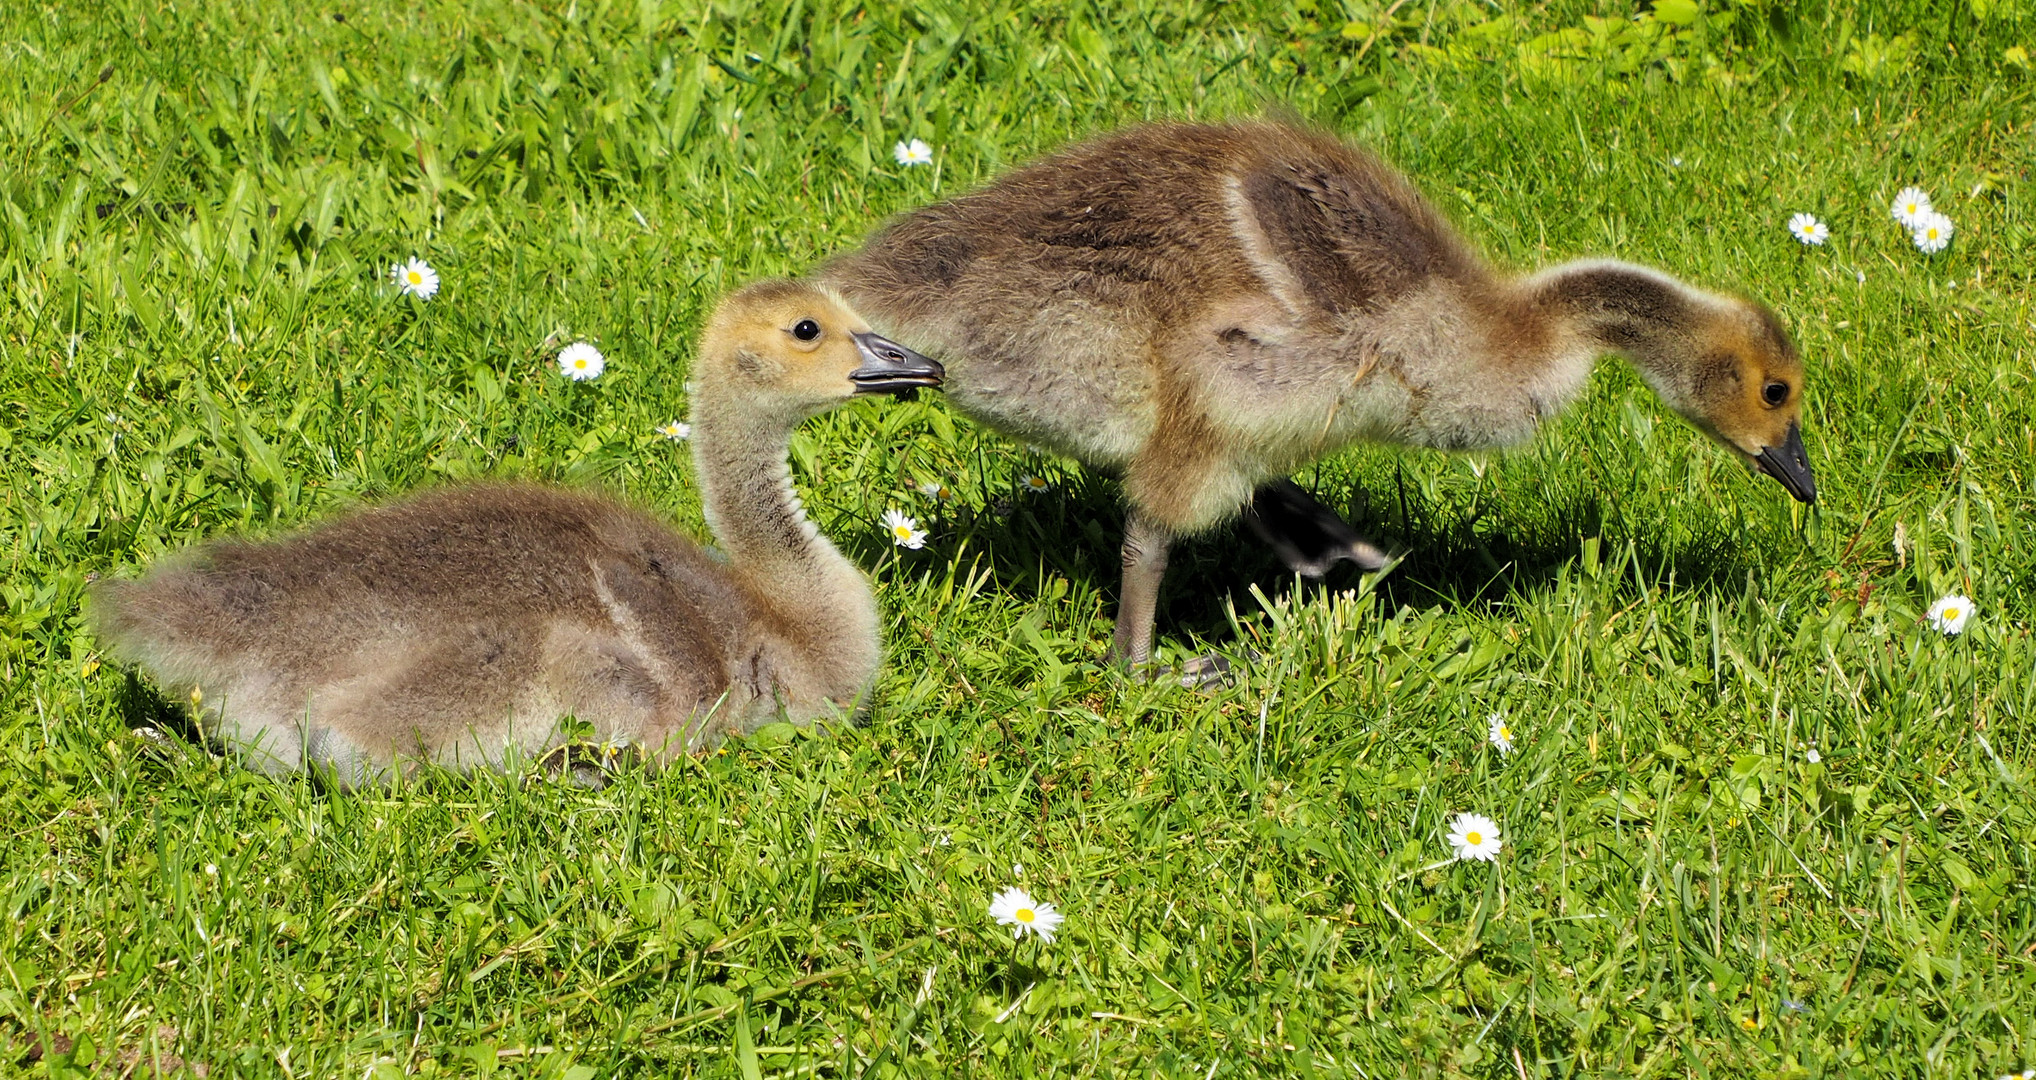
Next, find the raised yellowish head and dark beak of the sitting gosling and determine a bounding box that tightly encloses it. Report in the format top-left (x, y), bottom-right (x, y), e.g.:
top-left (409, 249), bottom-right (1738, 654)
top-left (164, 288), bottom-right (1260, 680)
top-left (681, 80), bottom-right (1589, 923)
top-left (694, 281), bottom-right (947, 422)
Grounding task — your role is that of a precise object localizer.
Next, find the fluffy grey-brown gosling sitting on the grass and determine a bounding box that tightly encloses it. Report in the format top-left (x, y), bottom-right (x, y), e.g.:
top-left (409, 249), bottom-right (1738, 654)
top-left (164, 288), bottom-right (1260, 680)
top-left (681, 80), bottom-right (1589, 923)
top-left (94, 281), bottom-right (941, 785)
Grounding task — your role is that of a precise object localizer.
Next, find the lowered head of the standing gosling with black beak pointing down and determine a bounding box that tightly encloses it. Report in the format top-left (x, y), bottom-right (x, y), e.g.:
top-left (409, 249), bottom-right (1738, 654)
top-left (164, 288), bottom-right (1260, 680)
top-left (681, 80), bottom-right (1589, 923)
top-left (1682, 300), bottom-right (1816, 503)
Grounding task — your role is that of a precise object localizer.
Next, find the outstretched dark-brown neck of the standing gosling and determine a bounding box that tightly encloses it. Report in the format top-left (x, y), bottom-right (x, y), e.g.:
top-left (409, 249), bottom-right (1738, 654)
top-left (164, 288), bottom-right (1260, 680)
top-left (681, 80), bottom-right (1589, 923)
top-left (1523, 259), bottom-right (1716, 412)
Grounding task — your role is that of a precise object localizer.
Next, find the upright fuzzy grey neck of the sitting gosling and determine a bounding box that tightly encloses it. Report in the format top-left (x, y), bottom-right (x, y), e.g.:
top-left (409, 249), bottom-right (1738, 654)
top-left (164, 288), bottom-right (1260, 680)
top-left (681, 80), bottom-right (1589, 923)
top-left (692, 397), bottom-right (875, 642)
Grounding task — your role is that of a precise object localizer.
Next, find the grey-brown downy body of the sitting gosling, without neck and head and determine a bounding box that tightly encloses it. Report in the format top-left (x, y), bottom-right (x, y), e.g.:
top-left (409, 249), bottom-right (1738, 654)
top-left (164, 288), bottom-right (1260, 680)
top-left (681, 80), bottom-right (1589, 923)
top-left (98, 485), bottom-right (770, 776)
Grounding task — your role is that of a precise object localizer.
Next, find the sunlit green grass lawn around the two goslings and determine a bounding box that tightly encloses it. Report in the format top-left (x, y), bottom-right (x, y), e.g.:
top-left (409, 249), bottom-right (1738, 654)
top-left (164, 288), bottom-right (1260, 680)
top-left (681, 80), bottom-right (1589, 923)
top-left (0, 0), bottom-right (2036, 1080)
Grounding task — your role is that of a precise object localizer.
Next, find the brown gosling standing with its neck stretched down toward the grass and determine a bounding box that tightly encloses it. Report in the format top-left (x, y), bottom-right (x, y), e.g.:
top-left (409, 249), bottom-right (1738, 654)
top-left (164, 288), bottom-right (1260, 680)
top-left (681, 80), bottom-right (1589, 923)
top-left (818, 122), bottom-right (1816, 664)
